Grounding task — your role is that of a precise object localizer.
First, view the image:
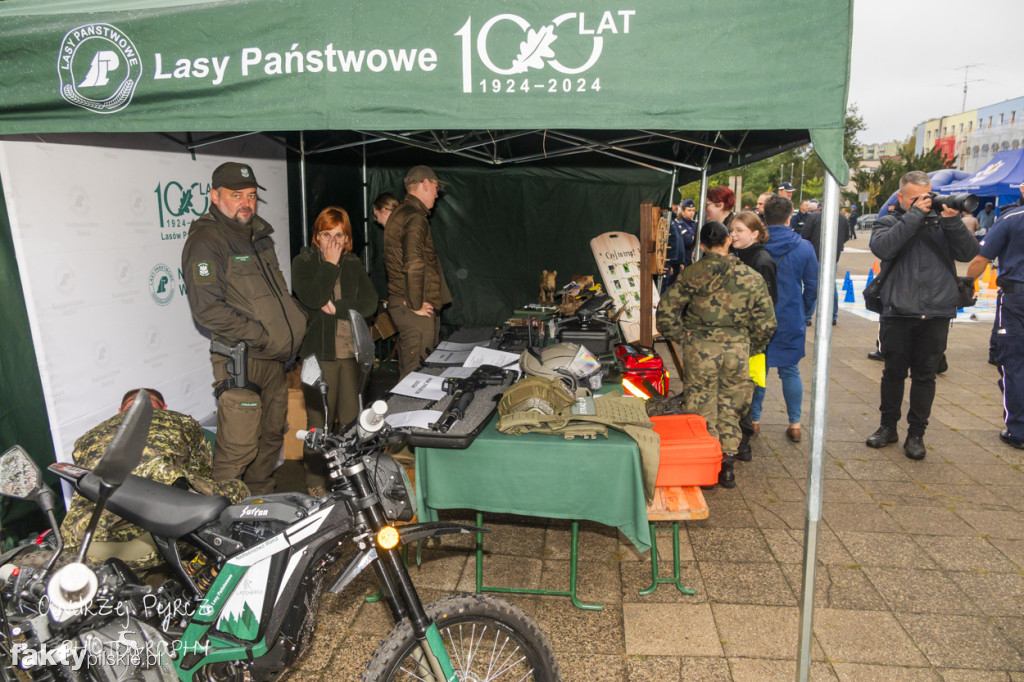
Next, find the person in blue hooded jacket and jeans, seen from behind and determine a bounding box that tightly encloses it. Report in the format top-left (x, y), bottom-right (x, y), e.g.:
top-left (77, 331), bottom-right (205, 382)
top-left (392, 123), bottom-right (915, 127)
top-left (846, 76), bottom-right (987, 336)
top-left (751, 197), bottom-right (818, 442)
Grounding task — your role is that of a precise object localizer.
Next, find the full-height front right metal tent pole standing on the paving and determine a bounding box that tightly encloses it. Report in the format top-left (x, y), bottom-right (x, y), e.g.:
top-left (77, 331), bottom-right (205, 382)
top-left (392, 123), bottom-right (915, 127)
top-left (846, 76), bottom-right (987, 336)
top-left (797, 172), bottom-right (839, 682)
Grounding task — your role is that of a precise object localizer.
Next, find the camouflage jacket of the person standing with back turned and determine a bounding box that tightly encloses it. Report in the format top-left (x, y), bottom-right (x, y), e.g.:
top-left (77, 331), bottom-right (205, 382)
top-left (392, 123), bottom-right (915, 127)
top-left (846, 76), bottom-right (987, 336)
top-left (657, 252), bottom-right (776, 355)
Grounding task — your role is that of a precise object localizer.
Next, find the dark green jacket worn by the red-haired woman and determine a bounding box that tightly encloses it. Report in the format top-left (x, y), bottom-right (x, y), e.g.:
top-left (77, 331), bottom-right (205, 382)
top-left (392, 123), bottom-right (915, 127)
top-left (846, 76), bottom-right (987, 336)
top-left (292, 246), bottom-right (377, 360)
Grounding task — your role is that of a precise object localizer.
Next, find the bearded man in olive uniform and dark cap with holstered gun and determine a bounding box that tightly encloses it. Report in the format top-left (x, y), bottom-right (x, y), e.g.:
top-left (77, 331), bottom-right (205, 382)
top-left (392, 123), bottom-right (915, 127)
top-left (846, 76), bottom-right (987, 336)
top-left (181, 162), bottom-right (306, 495)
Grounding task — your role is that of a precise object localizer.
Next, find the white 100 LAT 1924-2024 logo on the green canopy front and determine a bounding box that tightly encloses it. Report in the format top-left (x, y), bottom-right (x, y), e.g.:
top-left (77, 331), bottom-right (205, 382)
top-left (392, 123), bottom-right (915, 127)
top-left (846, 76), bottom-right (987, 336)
top-left (455, 9), bottom-right (636, 94)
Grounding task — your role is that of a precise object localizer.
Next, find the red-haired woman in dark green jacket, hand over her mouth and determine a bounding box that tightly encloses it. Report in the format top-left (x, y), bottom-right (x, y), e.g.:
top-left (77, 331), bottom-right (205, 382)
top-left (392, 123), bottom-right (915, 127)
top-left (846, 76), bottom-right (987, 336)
top-left (292, 206), bottom-right (378, 496)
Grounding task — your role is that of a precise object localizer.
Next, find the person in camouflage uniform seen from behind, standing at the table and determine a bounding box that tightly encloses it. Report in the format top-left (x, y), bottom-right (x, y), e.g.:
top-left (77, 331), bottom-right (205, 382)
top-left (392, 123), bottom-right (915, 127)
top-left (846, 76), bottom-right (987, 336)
top-left (657, 220), bottom-right (776, 487)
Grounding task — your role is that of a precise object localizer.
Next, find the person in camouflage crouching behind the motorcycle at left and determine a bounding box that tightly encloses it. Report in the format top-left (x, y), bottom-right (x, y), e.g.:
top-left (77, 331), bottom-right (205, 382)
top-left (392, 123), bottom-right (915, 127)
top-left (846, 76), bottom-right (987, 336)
top-left (60, 388), bottom-right (249, 570)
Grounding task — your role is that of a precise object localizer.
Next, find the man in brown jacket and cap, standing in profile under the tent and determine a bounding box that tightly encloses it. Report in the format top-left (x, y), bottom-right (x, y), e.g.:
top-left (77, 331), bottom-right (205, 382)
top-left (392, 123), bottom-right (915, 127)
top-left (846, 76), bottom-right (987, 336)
top-left (384, 166), bottom-right (452, 377)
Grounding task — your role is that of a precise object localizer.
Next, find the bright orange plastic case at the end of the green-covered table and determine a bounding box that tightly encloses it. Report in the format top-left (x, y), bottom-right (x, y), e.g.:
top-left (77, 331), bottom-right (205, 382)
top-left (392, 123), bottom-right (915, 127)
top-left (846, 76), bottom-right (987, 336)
top-left (650, 415), bottom-right (722, 487)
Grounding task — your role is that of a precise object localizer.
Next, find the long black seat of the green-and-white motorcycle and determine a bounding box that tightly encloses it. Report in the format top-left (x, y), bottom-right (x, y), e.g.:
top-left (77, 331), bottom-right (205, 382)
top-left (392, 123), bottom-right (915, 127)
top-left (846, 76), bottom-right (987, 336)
top-left (77, 473), bottom-right (230, 540)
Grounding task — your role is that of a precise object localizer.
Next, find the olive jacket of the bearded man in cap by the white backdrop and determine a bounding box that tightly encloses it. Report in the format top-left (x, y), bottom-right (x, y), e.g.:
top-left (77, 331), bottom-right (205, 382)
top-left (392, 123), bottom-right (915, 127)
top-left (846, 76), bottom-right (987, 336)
top-left (181, 206), bottom-right (306, 361)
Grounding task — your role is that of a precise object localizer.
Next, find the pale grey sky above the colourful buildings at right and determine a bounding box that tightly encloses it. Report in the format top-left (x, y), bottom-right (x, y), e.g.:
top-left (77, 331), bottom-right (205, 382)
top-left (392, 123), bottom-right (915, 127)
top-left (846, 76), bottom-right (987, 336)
top-left (849, 0), bottom-right (1024, 143)
